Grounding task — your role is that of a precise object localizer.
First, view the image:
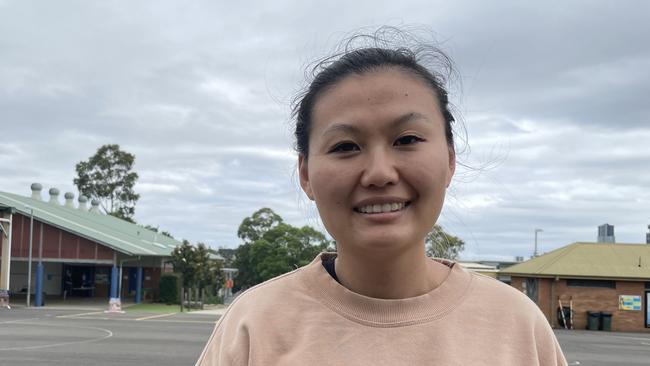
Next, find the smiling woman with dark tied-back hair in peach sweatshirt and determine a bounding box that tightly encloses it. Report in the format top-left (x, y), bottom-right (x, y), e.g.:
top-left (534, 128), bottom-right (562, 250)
top-left (198, 30), bottom-right (566, 365)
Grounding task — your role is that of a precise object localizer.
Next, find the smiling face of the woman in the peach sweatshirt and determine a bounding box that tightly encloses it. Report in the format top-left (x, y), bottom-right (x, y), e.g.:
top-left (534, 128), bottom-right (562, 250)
top-left (299, 68), bottom-right (455, 252)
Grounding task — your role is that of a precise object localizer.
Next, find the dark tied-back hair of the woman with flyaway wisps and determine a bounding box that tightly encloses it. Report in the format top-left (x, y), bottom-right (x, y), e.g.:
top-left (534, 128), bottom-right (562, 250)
top-left (292, 27), bottom-right (455, 158)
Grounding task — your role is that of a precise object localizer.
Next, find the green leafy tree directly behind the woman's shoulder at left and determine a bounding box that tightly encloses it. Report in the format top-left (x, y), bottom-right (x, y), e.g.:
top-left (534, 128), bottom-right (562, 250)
top-left (234, 208), bottom-right (332, 289)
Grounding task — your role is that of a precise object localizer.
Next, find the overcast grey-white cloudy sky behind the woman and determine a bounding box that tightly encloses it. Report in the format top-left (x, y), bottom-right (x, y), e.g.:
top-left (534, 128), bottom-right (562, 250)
top-left (0, 0), bottom-right (650, 259)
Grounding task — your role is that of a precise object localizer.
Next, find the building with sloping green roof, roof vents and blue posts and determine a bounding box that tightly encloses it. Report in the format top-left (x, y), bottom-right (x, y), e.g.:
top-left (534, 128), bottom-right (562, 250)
top-left (0, 183), bottom-right (181, 306)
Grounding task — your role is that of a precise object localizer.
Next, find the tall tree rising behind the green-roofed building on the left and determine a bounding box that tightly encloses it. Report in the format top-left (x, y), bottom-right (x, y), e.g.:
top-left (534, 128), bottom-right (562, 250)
top-left (73, 145), bottom-right (140, 222)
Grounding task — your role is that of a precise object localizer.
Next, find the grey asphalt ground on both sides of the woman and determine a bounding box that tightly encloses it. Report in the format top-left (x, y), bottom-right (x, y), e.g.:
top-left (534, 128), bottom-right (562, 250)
top-left (0, 308), bottom-right (650, 366)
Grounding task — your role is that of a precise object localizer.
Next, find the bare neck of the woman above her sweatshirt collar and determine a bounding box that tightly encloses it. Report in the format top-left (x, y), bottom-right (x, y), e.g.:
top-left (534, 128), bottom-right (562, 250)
top-left (335, 248), bottom-right (449, 299)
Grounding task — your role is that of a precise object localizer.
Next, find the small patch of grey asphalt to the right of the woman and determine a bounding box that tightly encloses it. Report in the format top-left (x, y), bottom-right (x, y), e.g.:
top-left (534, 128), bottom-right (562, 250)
top-left (555, 330), bottom-right (650, 366)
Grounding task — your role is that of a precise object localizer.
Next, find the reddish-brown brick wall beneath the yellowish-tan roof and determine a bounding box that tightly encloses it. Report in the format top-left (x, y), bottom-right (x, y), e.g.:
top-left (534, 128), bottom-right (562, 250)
top-left (512, 277), bottom-right (650, 332)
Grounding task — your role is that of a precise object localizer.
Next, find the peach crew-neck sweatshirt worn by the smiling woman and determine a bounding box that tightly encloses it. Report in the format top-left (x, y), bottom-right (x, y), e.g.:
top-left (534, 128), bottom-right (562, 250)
top-left (197, 253), bottom-right (566, 366)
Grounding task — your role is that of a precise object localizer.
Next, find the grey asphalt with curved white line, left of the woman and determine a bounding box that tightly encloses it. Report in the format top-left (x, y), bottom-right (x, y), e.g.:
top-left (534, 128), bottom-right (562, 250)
top-left (0, 308), bottom-right (218, 366)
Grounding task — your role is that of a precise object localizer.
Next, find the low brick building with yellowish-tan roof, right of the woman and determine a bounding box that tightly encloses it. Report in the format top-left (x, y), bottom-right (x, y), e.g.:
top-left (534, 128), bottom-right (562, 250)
top-left (499, 242), bottom-right (650, 332)
